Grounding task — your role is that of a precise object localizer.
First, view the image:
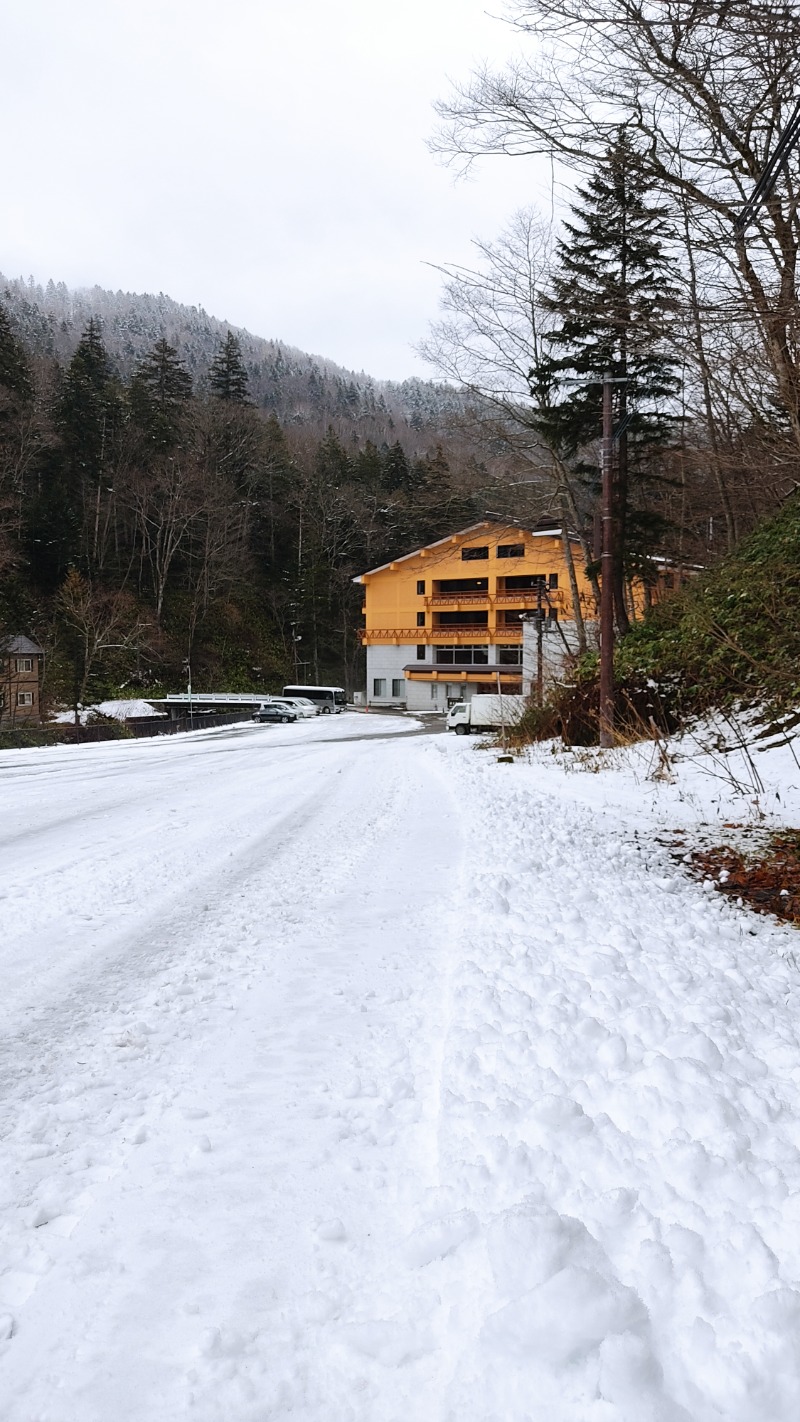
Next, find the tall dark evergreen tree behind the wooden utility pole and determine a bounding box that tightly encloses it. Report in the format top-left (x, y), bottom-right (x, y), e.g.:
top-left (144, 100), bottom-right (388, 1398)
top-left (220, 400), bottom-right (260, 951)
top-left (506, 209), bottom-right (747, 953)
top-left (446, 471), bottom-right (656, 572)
top-left (531, 128), bottom-right (678, 631)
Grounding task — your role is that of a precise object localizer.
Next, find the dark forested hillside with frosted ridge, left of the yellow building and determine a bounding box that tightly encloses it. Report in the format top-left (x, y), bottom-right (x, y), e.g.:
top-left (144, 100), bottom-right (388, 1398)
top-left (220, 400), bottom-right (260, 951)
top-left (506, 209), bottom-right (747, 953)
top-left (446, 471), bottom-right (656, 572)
top-left (0, 283), bottom-right (486, 704)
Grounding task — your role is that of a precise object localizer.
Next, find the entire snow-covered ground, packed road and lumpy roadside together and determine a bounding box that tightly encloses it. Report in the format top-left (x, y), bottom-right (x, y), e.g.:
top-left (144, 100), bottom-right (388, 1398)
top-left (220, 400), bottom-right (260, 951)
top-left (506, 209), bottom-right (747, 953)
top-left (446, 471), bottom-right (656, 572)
top-left (0, 715), bottom-right (800, 1422)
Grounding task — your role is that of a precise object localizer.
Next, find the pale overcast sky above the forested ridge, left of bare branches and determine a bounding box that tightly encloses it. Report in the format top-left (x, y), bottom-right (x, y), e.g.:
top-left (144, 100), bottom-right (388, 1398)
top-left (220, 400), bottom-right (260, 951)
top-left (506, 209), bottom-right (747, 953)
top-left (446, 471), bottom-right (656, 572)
top-left (0, 0), bottom-right (548, 378)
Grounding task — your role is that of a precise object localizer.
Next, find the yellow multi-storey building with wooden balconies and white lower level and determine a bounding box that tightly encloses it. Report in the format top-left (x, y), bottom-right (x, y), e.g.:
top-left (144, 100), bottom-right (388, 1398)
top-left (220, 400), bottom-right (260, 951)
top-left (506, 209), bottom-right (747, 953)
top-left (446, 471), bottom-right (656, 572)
top-left (355, 522), bottom-right (595, 711)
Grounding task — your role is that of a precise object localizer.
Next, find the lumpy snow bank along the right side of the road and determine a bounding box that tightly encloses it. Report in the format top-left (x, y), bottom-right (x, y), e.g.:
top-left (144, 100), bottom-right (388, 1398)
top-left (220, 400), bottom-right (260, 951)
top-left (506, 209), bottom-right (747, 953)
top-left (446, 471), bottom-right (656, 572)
top-left (406, 745), bottom-right (800, 1422)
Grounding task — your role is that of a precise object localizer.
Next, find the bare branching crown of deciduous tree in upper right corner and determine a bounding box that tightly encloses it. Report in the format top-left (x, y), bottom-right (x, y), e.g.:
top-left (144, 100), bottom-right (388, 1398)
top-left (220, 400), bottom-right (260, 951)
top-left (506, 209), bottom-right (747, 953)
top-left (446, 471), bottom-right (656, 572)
top-left (436, 0), bottom-right (800, 448)
